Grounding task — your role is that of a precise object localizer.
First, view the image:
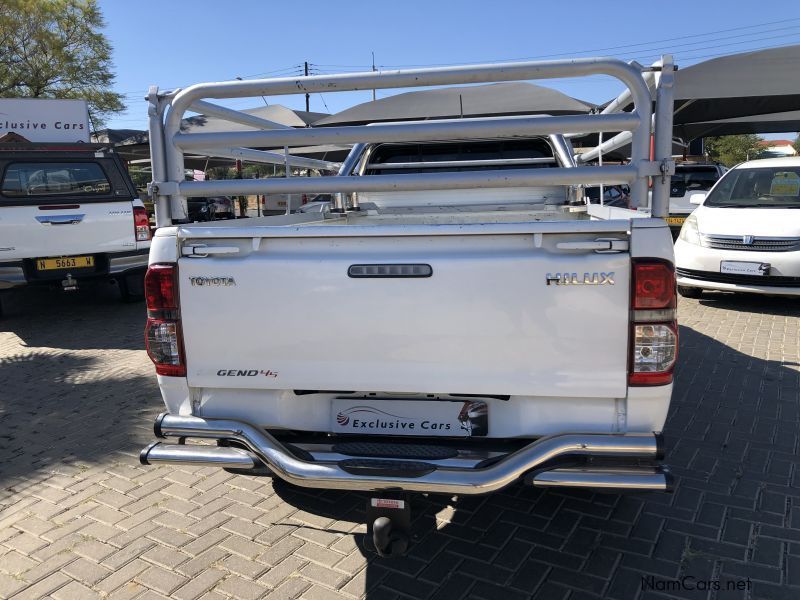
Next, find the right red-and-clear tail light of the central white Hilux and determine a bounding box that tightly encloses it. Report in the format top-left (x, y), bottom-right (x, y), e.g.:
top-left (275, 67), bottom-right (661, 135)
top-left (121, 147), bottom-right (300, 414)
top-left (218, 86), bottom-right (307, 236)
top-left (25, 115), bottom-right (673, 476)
top-left (628, 259), bottom-right (678, 386)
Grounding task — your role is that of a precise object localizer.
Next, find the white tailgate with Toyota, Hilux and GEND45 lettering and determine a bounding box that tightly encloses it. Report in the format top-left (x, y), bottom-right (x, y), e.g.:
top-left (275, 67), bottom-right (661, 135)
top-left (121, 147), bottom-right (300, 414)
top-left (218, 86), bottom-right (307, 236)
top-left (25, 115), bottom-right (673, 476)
top-left (179, 233), bottom-right (630, 398)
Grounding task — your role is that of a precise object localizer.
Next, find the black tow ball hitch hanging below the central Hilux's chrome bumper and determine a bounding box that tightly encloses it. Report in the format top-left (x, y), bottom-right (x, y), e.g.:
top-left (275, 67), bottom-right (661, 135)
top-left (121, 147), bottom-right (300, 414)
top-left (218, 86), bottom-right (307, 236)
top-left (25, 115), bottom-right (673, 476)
top-left (364, 496), bottom-right (411, 558)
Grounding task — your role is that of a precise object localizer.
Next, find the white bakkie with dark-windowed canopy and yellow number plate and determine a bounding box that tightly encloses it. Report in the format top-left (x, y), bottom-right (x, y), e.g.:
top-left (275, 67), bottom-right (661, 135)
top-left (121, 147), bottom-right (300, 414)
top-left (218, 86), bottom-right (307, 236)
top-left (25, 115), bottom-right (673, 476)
top-left (0, 143), bottom-right (151, 312)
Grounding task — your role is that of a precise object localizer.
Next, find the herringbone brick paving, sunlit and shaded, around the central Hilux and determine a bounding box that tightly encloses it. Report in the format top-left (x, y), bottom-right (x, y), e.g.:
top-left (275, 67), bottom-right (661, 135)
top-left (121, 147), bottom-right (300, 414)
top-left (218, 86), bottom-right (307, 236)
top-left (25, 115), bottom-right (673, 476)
top-left (0, 288), bottom-right (800, 600)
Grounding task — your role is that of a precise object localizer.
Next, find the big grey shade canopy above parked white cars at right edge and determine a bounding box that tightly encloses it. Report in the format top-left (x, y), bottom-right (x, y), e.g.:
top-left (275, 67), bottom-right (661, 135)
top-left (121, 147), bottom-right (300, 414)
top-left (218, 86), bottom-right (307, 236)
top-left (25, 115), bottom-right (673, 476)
top-left (674, 45), bottom-right (800, 125)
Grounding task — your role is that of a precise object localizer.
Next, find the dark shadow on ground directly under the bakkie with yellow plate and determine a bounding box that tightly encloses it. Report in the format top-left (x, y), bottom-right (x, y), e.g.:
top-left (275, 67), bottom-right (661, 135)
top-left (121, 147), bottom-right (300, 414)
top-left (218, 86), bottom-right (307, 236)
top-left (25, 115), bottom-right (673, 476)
top-left (0, 282), bottom-right (146, 350)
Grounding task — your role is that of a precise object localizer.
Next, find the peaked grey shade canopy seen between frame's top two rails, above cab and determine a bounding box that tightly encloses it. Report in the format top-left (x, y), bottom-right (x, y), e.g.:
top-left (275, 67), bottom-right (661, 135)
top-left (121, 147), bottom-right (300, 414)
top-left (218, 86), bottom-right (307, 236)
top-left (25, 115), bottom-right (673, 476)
top-left (314, 82), bottom-right (595, 127)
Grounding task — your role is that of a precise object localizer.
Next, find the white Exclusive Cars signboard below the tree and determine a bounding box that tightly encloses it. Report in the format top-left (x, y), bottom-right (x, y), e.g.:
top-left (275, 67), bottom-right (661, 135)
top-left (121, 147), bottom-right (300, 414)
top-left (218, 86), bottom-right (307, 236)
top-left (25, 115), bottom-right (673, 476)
top-left (0, 98), bottom-right (89, 143)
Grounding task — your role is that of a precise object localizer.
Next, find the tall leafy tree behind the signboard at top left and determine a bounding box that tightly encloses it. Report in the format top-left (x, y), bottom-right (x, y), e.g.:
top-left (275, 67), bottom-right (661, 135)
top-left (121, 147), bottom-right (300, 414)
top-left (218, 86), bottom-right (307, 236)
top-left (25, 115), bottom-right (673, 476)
top-left (0, 0), bottom-right (125, 129)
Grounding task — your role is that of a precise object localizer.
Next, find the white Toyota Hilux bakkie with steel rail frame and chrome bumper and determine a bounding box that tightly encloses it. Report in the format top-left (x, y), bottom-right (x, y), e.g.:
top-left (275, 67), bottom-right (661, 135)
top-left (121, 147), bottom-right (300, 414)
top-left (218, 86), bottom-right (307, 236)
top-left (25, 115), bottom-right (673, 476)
top-left (140, 59), bottom-right (678, 553)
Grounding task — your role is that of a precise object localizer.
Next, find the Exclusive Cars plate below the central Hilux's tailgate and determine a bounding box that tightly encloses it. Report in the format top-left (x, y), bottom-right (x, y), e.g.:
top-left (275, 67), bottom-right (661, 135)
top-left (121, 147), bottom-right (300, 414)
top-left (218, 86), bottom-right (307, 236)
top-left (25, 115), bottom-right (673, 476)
top-left (331, 398), bottom-right (489, 437)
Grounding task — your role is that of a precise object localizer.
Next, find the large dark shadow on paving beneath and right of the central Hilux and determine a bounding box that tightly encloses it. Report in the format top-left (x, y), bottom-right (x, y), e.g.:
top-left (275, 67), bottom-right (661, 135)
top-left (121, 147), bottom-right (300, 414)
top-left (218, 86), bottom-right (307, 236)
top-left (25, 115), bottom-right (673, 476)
top-left (264, 324), bottom-right (800, 600)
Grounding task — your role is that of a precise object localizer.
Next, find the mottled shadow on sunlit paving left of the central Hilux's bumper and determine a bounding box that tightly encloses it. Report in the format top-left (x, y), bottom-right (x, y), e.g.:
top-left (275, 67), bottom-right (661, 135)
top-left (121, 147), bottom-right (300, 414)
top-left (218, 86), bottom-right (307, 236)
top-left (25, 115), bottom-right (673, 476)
top-left (0, 352), bottom-right (158, 496)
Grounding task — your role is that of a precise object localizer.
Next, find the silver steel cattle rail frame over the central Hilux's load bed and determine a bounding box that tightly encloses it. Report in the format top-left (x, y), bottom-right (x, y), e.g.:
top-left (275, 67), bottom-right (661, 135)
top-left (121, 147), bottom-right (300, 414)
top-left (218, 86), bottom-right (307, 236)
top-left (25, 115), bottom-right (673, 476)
top-left (148, 56), bottom-right (674, 227)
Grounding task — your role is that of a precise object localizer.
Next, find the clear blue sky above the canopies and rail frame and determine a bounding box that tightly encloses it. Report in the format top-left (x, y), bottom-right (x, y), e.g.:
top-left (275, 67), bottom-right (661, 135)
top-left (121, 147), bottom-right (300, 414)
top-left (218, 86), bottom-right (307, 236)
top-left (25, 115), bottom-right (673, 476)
top-left (100, 0), bottom-right (800, 137)
